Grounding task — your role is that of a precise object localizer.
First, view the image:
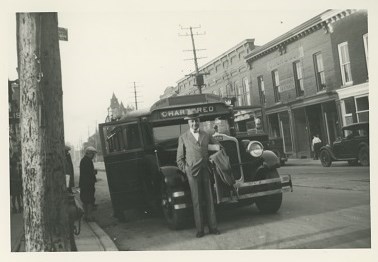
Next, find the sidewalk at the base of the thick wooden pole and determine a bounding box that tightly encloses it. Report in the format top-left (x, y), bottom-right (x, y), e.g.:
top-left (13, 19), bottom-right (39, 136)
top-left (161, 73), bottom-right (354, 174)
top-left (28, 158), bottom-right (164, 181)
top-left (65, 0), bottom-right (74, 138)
top-left (10, 213), bottom-right (118, 252)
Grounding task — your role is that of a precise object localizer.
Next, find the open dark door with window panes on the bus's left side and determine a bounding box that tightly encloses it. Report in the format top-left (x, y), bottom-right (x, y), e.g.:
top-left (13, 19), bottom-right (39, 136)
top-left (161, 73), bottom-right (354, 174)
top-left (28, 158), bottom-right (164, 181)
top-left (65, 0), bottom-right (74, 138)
top-left (100, 121), bottom-right (144, 212)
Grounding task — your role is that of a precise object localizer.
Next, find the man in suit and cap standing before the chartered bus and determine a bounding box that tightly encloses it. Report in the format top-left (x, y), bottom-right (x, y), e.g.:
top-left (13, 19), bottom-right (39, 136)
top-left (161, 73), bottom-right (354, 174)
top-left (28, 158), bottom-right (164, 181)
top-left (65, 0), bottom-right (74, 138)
top-left (176, 112), bottom-right (220, 237)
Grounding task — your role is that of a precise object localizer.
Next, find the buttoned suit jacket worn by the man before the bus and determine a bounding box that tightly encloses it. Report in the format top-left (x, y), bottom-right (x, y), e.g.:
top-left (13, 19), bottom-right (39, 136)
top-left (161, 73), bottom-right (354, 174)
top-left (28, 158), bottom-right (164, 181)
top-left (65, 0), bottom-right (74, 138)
top-left (176, 129), bottom-right (218, 176)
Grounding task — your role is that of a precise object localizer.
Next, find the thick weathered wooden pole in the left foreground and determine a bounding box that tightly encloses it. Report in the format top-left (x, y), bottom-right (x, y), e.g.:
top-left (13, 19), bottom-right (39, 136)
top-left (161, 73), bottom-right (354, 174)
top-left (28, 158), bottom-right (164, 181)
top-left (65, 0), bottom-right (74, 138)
top-left (16, 13), bottom-right (71, 251)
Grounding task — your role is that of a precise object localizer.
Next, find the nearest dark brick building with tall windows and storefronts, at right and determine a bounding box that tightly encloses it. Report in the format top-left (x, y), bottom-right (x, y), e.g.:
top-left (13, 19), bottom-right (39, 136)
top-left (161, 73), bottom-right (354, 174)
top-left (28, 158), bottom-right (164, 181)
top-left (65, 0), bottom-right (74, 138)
top-left (245, 10), bottom-right (368, 157)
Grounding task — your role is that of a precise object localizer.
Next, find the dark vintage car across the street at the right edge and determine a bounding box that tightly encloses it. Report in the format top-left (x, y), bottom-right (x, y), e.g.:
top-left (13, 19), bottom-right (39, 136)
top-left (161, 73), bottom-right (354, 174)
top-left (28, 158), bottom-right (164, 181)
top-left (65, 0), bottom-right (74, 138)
top-left (320, 122), bottom-right (370, 167)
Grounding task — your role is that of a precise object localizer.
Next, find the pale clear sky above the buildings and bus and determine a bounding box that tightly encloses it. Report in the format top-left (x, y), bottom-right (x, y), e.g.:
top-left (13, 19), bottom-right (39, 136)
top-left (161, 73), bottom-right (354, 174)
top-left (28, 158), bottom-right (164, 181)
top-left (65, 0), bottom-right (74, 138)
top-left (8, 1), bottom-right (372, 146)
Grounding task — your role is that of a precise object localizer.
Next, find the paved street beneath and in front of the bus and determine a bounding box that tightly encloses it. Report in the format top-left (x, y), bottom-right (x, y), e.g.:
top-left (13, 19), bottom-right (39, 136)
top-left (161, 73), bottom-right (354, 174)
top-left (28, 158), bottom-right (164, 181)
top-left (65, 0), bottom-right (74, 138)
top-left (85, 160), bottom-right (371, 250)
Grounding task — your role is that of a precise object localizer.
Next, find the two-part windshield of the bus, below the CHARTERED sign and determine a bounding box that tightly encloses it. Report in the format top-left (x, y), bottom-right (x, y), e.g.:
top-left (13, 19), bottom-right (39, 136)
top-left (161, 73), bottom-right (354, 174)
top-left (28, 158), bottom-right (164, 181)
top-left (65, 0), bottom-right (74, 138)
top-left (153, 118), bottom-right (230, 143)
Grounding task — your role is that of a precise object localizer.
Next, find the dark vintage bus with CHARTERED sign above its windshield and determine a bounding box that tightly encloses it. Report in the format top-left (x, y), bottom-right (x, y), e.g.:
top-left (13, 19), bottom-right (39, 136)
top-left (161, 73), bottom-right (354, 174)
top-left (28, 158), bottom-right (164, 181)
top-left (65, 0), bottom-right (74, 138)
top-left (99, 94), bottom-right (292, 229)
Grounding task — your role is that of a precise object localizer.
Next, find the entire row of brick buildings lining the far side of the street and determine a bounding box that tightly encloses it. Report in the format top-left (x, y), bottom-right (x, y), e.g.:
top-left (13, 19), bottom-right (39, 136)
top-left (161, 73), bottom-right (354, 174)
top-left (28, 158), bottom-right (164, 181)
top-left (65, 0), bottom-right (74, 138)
top-left (164, 10), bottom-right (369, 158)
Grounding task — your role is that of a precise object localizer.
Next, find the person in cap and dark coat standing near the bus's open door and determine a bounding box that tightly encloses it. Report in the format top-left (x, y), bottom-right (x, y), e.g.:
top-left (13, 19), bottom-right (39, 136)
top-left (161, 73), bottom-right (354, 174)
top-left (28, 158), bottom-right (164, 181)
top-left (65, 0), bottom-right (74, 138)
top-left (79, 146), bottom-right (97, 221)
